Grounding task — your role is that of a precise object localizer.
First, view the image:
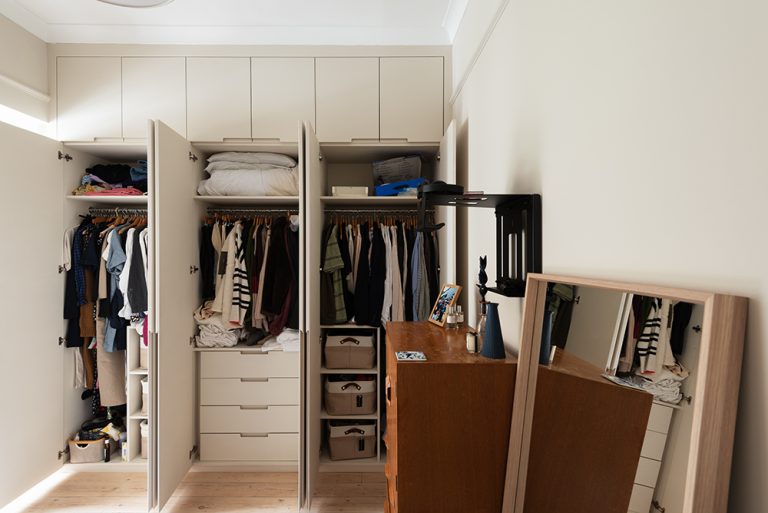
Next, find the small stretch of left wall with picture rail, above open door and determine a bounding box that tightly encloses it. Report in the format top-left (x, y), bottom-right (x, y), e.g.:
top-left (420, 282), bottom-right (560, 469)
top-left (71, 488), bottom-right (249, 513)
top-left (0, 15), bottom-right (48, 121)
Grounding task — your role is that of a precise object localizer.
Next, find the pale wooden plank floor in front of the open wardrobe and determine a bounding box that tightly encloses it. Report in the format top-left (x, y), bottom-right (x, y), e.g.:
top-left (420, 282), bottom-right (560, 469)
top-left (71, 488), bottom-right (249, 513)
top-left (19, 472), bottom-right (386, 513)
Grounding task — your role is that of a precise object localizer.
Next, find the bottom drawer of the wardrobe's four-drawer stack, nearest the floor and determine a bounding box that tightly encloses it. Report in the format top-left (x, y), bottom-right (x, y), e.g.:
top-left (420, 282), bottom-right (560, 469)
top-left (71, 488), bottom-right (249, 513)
top-left (200, 433), bottom-right (299, 461)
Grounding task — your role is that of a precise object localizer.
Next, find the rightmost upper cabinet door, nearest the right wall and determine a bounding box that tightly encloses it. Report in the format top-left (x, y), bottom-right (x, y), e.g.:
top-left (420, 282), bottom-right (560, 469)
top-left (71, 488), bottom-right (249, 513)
top-left (381, 57), bottom-right (445, 142)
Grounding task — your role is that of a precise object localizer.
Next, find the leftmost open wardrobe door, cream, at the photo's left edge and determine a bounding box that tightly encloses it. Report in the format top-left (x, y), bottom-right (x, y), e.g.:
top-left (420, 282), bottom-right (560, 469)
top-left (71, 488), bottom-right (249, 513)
top-left (0, 123), bottom-right (63, 509)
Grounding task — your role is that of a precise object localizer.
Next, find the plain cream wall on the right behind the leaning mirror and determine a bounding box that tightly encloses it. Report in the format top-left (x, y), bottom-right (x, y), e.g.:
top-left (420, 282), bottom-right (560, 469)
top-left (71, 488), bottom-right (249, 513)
top-left (454, 0), bottom-right (768, 513)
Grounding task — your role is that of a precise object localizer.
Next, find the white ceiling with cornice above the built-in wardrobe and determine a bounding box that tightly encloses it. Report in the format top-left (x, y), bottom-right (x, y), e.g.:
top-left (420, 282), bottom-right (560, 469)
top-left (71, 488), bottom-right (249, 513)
top-left (0, 0), bottom-right (468, 45)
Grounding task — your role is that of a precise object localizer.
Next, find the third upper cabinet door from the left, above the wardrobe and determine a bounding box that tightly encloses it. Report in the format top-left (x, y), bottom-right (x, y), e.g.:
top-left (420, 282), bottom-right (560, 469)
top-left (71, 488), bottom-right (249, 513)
top-left (187, 57), bottom-right (251, 141)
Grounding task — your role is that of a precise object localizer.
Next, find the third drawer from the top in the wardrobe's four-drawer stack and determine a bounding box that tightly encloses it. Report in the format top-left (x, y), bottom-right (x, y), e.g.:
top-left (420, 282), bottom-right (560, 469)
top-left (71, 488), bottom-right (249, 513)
top-left (200, 406), bottom-right (299, 433)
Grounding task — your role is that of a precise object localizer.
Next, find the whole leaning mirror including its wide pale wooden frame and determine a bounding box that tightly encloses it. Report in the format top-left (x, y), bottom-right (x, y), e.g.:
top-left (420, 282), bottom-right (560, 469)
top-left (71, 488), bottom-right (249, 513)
top-left (504, 275), bottom-right (747, 513)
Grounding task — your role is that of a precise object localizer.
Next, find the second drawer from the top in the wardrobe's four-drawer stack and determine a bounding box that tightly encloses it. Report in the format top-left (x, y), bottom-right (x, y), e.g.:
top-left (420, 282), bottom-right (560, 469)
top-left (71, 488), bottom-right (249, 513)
top-left (200, 378), bottom-right (300, 406)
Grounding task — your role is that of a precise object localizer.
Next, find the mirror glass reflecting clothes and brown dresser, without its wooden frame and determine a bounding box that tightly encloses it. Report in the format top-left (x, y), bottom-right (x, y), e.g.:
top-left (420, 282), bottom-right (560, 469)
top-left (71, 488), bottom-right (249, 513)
top-left (525, 282), bottom-right (703, 513)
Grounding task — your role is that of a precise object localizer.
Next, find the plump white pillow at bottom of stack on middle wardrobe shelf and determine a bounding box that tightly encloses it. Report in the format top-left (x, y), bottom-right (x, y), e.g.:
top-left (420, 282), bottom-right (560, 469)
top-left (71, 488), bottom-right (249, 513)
top-left (197, 168), bottom-right (299, 196)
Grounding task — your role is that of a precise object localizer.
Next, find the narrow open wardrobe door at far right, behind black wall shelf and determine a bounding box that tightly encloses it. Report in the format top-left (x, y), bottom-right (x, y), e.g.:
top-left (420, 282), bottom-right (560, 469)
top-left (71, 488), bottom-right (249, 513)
top-left (435, 121), bottom-right (457, 283)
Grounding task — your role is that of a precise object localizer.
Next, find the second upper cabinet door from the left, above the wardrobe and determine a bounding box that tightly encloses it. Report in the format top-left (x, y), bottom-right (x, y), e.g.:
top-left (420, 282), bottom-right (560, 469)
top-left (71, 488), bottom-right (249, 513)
top-left (123, 57), bottom-right (187, 139)
